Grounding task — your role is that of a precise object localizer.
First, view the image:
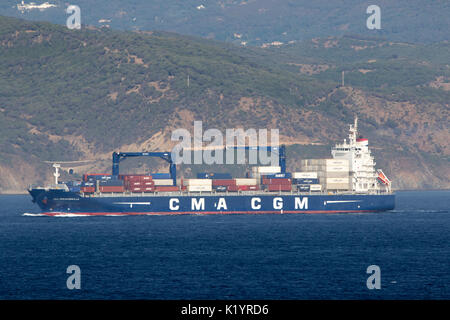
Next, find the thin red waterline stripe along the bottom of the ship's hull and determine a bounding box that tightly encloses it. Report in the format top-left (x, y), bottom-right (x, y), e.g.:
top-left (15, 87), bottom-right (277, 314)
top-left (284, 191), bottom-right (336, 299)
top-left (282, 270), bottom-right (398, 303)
top-left (42, 210), bottom-right (378, 216)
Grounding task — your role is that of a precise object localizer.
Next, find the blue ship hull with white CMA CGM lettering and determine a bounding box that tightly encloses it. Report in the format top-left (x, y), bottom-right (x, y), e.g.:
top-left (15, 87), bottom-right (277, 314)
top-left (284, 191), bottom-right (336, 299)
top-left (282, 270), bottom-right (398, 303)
top-left (29, 189), bottom-right (395, 215)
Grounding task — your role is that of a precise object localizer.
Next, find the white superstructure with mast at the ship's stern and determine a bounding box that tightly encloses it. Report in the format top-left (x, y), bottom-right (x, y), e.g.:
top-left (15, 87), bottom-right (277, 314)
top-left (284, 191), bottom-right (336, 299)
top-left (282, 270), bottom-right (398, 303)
top-left (331, 117), bottom-right (391, 193)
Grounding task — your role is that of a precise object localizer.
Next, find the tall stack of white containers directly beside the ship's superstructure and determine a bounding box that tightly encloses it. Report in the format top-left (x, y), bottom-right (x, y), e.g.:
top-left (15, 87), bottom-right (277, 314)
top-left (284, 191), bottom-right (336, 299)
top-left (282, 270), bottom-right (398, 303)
top-left (300, 159), bottom-right (351, 191)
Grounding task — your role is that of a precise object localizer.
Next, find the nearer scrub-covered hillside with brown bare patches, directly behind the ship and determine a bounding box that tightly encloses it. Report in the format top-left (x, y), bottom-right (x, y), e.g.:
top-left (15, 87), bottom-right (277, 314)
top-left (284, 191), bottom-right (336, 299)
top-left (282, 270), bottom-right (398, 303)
top-left (0, 17), bottom-right (450, 192)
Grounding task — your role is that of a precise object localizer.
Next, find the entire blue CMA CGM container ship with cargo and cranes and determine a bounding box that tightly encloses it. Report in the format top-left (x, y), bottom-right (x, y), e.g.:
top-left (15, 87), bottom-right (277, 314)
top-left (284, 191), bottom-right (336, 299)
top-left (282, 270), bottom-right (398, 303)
top-left (28, 118), bottom-right (395, 216)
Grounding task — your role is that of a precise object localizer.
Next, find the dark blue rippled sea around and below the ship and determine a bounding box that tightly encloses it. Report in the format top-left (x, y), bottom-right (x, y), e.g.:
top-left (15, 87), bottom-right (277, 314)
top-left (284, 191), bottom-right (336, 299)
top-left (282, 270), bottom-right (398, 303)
top-left (0, 191), bottom-right (450, 299)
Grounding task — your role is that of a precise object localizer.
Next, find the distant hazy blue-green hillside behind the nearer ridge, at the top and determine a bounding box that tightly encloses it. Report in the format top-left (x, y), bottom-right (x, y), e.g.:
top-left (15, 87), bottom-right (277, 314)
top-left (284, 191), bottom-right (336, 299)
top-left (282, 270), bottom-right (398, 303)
top-left (0, 0), bottom-right (450, 45)
